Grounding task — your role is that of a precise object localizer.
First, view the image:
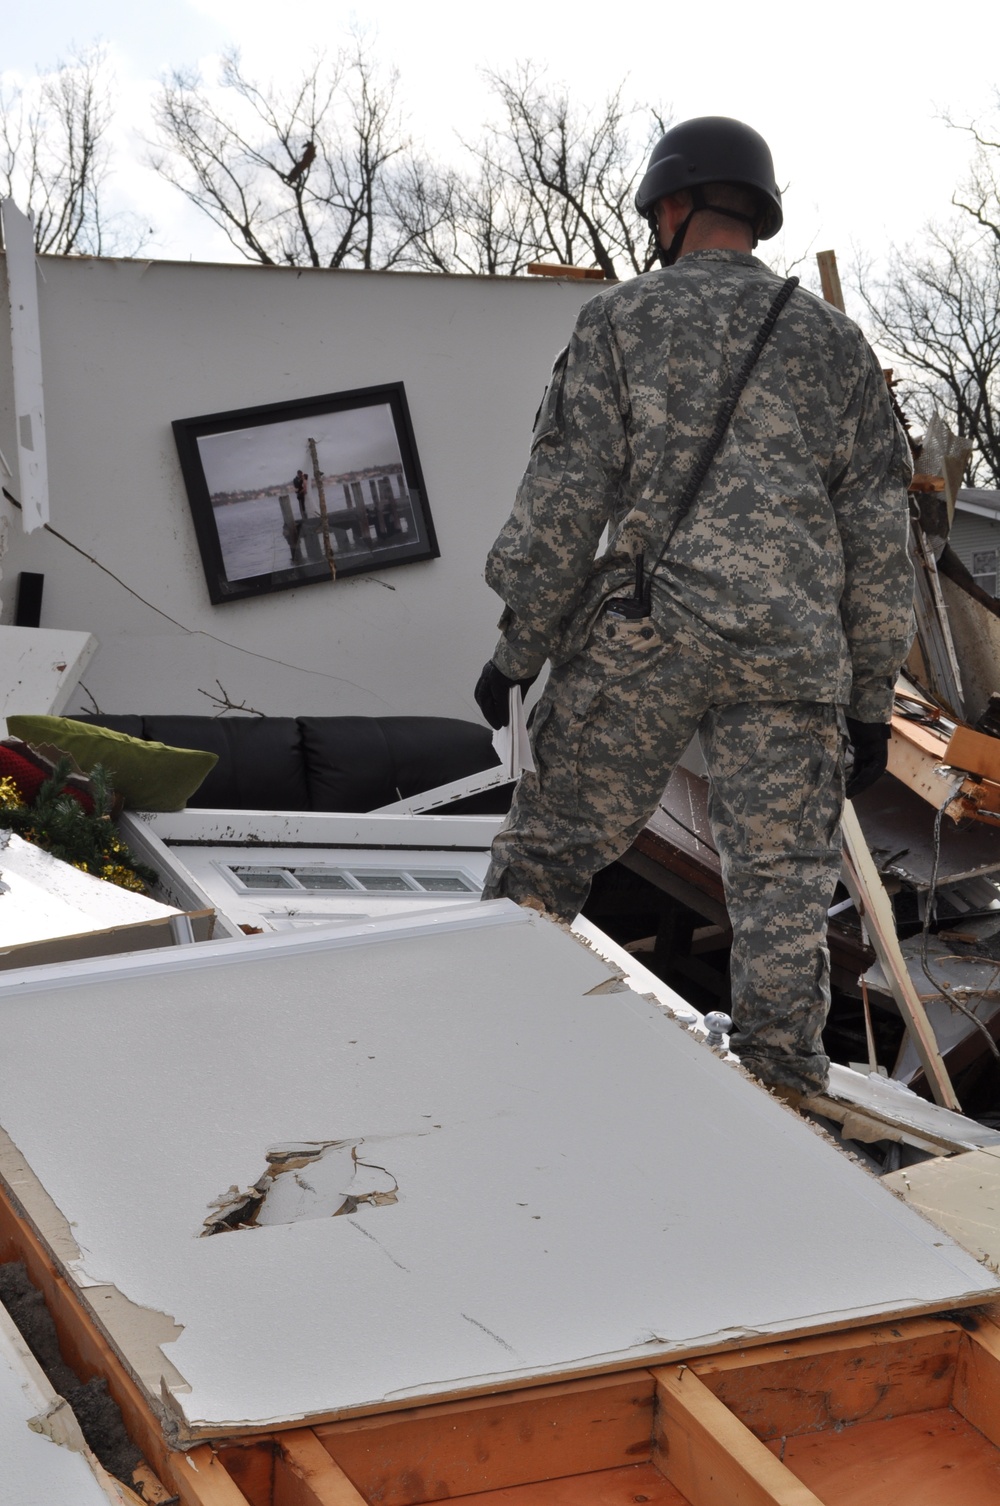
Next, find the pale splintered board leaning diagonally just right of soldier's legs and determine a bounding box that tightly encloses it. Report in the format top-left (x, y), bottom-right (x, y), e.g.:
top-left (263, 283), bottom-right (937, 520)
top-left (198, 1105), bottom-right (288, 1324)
top-left (843, 800), bottom-right (962, 1113)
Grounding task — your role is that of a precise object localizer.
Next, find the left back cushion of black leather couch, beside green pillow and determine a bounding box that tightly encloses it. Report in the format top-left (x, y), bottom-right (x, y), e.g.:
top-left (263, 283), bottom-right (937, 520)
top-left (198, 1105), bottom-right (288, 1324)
top-left (143, 717), bottom-right (309, 810)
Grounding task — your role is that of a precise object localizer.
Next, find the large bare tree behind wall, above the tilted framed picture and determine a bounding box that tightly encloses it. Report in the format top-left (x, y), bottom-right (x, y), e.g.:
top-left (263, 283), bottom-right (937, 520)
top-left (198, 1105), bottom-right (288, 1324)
top-left (151, 42), bottom-right (424, 270)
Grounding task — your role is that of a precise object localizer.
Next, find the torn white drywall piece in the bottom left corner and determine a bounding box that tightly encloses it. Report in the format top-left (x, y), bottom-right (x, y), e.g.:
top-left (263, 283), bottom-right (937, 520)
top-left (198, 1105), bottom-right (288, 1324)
top-left (0, 1306), bottom-right (125, 1506)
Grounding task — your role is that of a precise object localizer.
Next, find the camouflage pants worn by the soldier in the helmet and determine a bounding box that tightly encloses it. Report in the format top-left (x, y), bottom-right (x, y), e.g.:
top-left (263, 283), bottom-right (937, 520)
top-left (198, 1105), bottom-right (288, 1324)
top-left (483, 616), bottom-right (843, 1092)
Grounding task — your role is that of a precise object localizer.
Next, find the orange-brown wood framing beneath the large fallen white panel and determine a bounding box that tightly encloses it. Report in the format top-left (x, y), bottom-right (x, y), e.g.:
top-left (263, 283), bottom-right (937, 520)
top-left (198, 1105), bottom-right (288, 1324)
top-left (0, 1199), bottom-right (1000, 1506)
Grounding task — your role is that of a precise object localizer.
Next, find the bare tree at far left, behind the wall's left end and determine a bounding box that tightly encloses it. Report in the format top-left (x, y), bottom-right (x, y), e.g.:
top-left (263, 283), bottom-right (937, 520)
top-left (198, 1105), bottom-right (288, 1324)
top-left (0, 47), bottom-right (146, 256)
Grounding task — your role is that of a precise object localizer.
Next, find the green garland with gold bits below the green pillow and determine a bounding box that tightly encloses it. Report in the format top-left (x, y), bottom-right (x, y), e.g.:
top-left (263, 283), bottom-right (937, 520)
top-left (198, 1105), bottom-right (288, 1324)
top-left (0, 758), bottom-right (157, 895)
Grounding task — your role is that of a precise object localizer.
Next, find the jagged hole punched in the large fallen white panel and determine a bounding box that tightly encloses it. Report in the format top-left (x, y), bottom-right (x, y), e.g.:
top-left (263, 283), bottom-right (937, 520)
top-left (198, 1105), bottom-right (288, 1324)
top-left (202, 1140), bottom-right (399, 1235)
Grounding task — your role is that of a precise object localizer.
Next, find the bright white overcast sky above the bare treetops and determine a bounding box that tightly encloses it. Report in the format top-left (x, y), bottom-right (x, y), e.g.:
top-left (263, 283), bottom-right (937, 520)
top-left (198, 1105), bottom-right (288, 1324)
top-left (3, 0), bottom-right (1000, 314)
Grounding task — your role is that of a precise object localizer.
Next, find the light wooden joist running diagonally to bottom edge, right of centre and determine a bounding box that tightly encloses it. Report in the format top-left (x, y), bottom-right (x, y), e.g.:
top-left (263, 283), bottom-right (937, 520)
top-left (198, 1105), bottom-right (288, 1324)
top-left (654, 1364), bottom-right (824, 1506)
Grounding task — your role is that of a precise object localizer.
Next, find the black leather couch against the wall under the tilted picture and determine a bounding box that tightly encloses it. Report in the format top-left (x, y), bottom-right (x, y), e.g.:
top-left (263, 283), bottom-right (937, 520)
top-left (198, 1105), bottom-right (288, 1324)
top-left (77, 714), bottom-right (512, 815)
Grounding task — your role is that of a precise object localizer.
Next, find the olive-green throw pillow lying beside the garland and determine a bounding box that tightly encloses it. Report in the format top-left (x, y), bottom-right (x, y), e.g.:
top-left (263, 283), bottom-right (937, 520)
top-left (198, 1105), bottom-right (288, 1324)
top-left (8, 715), bottom-right (218, 810)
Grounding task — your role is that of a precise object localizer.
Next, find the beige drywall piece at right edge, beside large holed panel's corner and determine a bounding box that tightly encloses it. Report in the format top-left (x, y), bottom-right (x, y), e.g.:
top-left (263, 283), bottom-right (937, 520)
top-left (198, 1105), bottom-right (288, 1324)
top-left (883, 1148), bottom-right (1000, 1271)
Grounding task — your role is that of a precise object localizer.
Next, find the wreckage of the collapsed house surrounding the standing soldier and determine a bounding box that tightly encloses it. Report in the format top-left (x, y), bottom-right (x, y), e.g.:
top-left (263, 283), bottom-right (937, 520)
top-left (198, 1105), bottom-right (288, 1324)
top-left (7, 221), bottom-right (1000, 1506)
